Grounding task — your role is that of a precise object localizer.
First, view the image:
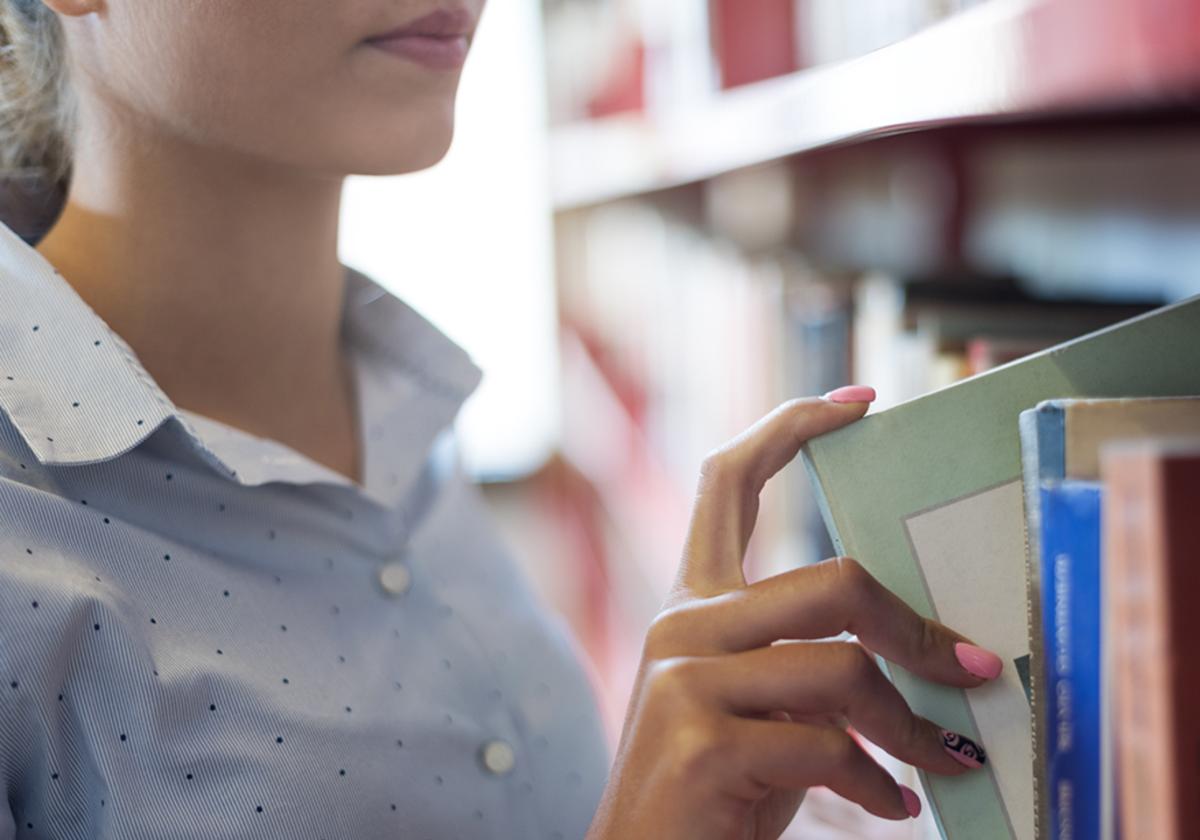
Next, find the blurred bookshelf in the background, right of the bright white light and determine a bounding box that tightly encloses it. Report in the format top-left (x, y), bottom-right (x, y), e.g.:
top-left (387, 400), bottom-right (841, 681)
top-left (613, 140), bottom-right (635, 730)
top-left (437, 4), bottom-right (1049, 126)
top-left (480, 0), bottom-right (1200, 840)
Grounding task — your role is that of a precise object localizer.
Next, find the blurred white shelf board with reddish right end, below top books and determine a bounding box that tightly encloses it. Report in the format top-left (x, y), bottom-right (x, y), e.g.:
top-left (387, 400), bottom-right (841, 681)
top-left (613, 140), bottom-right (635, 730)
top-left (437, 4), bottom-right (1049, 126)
top-left (550, 0), bottom-right (1200, 209)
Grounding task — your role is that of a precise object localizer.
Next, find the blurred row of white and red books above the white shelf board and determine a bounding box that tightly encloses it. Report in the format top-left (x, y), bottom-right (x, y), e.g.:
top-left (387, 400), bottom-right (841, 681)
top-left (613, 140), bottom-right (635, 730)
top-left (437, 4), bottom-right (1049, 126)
top-left (544, 0), bottom-right (985, 124)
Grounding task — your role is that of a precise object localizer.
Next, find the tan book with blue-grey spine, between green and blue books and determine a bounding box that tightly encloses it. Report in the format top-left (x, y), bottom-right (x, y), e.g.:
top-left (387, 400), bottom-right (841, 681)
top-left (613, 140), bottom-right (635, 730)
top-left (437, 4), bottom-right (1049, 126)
top-left (1019, 397), bottom-right (1200, 823)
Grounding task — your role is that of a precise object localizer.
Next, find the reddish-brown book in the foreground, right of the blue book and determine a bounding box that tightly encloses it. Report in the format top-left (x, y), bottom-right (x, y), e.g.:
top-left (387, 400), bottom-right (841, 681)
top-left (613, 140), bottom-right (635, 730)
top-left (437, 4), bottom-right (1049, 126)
top-left (1100, 439), bottom-right (1200, 840)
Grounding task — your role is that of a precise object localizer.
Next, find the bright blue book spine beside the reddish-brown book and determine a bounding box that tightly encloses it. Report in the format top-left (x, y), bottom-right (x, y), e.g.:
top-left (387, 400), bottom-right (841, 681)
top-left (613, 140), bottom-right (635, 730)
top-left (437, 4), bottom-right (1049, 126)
top-left (1040, 481), bottom-right (1103, 840)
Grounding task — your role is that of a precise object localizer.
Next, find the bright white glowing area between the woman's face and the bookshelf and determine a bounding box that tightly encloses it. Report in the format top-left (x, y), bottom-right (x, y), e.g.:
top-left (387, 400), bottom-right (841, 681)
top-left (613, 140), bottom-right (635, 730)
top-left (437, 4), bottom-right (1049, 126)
top-left (340, 0), bottom-right (559, 478)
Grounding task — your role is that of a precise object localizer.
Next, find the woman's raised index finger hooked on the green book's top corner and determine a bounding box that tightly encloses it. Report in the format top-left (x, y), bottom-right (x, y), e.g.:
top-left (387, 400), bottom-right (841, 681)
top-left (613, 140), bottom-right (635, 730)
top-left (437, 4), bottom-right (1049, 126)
top-left (678, 388), bottom-right (875, 595)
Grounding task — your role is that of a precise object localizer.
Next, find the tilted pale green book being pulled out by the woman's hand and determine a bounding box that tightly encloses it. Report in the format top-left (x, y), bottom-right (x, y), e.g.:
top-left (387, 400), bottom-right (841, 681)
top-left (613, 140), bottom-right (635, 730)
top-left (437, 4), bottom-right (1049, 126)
top-left (802, 296), bottom-right (1200, 840)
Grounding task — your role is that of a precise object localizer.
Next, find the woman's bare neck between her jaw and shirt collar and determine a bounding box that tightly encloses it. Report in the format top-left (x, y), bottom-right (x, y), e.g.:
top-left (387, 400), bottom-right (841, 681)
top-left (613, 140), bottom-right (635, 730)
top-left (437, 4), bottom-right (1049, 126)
top-left (36, 102), bottom-right (361, 480)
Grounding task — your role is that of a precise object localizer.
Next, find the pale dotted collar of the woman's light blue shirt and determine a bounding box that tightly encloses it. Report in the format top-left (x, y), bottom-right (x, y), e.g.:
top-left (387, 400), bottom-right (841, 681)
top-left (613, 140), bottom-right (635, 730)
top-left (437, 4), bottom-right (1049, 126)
top-left (0, 219), bottom-right (482, 506)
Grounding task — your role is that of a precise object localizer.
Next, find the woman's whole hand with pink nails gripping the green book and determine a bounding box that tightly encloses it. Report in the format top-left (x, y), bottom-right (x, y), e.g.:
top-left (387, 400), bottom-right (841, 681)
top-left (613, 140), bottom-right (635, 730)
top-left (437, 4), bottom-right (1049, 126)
top-left (588, 389), bottom-right (1000, 840)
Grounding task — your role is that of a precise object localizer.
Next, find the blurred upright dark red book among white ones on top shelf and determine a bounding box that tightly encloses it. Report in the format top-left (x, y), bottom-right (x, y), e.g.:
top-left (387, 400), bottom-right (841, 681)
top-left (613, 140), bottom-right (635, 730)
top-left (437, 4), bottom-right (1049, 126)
top-left (709, 0), bottom-right (798, 88)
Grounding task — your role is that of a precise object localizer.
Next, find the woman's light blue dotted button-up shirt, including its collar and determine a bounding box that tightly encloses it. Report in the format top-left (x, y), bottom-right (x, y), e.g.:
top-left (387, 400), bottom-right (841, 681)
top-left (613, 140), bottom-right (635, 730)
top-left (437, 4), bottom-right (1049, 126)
top-left (0, 226), bottom-right (608, 840)
